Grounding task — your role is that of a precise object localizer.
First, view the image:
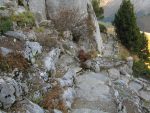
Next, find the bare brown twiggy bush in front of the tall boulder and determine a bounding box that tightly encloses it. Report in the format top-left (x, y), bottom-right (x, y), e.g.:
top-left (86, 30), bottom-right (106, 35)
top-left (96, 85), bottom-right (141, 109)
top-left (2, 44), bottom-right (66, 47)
top-left (51, 8), bottom-right (95, 42)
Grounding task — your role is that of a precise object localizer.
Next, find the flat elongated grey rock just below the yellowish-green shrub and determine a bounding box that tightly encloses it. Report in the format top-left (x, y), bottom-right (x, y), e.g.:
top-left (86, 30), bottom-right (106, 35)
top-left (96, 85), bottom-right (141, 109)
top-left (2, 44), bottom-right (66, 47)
top-left (5, 31), bottom-right (27, 41)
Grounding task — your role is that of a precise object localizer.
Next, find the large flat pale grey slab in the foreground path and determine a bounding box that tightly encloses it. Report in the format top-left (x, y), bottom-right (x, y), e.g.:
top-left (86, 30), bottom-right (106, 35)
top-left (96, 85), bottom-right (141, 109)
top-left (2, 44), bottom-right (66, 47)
top-left (77, 73), bottom-right (110, 101)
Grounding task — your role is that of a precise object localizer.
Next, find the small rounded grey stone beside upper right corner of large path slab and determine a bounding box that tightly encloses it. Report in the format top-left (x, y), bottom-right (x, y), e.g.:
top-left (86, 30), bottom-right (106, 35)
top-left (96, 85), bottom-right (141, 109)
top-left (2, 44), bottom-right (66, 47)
top-left (108, 68), bottom-right (120, 80)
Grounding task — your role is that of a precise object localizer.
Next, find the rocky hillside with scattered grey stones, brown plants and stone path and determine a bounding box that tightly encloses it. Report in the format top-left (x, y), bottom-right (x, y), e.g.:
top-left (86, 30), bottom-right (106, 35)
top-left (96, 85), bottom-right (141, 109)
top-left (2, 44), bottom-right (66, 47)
top-left (0, 0), bottom-right (150, 113)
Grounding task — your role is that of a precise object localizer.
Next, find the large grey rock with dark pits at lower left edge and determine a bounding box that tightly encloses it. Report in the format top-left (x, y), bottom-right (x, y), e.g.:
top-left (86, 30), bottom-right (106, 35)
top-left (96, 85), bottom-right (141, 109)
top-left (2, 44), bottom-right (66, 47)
top-left (0, 78), bottom-right (24, 109)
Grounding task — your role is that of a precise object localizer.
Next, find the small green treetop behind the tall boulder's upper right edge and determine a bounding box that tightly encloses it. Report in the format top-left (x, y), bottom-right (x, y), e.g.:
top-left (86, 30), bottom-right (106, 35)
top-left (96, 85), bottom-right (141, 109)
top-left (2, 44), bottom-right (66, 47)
top-left (92, 0), bottom-right (104, 19)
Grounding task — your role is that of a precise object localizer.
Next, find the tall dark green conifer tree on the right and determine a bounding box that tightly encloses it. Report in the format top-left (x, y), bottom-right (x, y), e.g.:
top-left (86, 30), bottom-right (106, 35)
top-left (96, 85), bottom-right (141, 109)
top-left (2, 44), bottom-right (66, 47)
top-left (113, 0), bottom-right (149, 59)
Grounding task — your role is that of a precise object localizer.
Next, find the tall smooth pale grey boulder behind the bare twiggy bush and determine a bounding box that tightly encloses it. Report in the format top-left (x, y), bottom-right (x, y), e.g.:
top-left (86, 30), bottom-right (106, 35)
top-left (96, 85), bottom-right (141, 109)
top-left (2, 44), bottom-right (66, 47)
top-left (46, 0), bottom-right (102, 52)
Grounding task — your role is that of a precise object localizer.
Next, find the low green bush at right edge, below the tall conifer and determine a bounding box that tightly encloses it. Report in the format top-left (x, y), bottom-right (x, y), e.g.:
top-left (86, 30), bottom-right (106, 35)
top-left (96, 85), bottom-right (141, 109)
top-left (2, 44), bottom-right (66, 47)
top-left (133, 60), bottom-right (150, 78)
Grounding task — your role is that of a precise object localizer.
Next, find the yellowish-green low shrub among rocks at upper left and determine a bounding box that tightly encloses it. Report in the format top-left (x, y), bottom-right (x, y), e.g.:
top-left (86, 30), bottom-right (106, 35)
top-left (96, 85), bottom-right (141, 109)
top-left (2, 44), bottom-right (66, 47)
top-left (12, 11), bottom-right (35, 27)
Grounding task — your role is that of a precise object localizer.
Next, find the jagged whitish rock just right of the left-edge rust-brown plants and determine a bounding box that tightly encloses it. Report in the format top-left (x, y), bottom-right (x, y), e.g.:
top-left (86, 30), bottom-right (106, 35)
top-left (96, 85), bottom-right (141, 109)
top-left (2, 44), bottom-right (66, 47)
top-left (24, 41), bottom-right (42, 63)
